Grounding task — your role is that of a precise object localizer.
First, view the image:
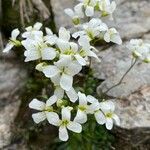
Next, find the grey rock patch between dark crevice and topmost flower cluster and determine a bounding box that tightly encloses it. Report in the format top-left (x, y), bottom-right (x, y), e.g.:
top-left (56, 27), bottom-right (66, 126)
top-left (51, 0), bottom-right (76, 30)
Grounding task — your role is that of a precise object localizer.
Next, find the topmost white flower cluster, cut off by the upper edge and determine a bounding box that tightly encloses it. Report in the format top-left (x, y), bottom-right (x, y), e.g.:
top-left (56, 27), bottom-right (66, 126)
top-left (65, 0), bottom-right (116, 25)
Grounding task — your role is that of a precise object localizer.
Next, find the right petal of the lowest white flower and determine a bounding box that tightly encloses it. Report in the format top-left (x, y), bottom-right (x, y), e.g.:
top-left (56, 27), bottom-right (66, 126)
top-left (67, 121), bottom-right (82, 133)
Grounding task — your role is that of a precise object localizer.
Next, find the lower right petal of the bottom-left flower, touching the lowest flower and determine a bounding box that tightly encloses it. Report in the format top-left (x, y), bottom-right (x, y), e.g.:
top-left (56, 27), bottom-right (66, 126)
top-left (46, 112), bottom-right (60, 126)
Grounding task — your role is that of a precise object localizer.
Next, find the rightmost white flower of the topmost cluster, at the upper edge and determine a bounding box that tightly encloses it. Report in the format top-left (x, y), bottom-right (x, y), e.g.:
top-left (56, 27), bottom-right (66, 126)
top-left (99, 0), bottom-right (116, 19)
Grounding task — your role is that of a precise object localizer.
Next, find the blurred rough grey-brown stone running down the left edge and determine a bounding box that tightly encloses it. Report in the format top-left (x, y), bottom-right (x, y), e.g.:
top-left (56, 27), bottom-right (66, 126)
top-left (0, 33), bottom-right (27, 149)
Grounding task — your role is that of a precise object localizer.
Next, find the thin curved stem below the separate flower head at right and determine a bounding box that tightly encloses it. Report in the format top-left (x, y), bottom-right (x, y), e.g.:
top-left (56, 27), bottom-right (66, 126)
top-left (104, 59), bottom-right (137, 94)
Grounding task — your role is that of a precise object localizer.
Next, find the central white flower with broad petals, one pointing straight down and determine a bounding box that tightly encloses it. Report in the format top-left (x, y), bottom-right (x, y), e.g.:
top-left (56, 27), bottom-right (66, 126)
top-left (43, 57), bottom-right (82, 91)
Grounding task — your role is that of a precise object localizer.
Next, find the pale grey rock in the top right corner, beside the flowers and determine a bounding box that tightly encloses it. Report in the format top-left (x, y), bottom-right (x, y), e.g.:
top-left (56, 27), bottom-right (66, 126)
top-left (111, 0), bottom-right (150, 39)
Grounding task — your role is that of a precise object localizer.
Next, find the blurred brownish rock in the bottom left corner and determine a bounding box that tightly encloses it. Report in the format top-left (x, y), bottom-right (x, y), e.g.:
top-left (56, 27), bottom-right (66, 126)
top-left (0, 101), bottom-right (20, 148)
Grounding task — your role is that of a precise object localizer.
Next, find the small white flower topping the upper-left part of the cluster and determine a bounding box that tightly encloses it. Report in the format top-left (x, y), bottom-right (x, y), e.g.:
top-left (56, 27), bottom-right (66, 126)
top-left (22, 22), bottom-right (43, 39)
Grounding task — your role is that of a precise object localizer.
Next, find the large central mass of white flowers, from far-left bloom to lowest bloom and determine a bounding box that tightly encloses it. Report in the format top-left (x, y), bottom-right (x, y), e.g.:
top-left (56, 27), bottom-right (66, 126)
top-left (4, 22), bottom-right (119, 141)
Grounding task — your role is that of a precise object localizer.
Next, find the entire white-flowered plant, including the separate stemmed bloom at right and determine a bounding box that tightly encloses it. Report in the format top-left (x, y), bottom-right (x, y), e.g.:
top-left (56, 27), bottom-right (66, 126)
top-left (3, 0), bottom-right (150, 145)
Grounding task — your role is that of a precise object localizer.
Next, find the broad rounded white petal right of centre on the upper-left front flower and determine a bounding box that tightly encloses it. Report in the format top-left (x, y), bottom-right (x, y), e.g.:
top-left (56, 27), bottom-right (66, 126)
top-left (42, 47), bottom-right (56, 60)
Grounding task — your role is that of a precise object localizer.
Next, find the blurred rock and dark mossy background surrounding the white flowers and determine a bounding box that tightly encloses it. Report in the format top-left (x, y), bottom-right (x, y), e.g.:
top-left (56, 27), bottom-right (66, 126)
top-left (0, 0), bottom-right (150, 150)
